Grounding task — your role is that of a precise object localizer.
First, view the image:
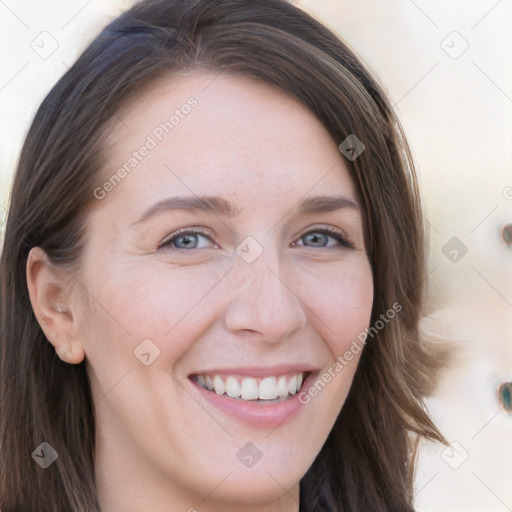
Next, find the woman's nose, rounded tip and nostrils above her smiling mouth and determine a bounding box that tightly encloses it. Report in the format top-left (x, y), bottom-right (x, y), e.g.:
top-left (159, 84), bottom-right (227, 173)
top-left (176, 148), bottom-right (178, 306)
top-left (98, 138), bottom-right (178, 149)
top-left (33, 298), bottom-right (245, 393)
top-left (225, 246), bottom-right (307, 343)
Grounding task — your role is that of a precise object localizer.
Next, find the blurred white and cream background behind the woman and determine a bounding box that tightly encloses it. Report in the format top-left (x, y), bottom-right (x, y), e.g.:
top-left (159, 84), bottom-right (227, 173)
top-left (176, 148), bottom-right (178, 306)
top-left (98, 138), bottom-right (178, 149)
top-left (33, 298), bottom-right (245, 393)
top-left (0, 0), bottom-right (512, 512)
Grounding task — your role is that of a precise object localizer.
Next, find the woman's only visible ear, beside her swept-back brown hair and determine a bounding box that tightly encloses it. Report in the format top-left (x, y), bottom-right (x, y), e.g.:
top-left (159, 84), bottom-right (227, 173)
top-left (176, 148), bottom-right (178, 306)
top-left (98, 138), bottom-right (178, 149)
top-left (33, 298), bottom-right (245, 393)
top-left (26, 247), bottom-right (85, 364)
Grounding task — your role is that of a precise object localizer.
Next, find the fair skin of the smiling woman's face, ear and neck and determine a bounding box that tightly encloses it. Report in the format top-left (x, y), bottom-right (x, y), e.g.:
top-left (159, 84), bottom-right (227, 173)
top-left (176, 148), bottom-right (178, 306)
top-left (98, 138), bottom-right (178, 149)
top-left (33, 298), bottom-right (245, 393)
top-left (27, 71), bottom-right (373, 512)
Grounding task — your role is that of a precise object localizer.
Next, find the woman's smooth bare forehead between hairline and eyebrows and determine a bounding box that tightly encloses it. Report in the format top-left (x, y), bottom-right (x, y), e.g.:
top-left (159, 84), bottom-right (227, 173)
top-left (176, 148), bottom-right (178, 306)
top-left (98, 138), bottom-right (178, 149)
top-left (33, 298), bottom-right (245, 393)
top-left (94, 71), bottom-right (356, 216)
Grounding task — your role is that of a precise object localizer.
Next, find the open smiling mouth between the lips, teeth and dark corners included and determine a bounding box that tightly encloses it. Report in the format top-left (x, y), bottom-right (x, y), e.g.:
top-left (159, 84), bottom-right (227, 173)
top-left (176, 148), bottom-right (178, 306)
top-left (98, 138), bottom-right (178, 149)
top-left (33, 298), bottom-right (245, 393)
top-left (189, 371), bottom-right (311, 404)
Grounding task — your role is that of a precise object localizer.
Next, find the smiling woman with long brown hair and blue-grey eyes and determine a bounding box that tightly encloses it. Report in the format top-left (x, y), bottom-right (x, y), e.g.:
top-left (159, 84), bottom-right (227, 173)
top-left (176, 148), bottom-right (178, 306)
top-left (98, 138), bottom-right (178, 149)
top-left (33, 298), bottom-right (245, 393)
top-left (0, 0), bottom-right (444, 512)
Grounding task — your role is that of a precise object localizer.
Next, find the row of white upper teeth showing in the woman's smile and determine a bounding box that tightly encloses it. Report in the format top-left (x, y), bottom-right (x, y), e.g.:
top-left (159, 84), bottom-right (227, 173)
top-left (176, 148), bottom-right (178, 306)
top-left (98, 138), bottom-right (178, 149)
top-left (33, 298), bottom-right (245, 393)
top-left (196, 372), bottom-right (304, 400)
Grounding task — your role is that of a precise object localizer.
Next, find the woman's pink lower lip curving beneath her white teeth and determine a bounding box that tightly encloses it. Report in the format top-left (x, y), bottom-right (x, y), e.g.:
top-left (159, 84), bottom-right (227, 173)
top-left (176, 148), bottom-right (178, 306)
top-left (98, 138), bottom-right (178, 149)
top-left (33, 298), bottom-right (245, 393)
top-left (190, 374), bottom-right (312, 429)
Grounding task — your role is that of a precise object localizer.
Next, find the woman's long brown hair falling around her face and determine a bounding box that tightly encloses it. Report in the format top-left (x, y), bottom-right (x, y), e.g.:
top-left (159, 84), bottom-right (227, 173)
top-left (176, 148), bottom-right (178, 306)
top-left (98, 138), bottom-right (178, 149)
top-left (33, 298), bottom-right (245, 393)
top-left (0, 0), bottom-right (444, 512)
